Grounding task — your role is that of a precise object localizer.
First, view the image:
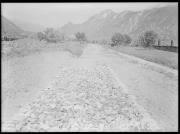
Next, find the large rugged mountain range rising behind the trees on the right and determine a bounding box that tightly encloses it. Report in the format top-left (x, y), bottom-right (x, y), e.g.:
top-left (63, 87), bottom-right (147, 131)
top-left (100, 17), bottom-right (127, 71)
top-left (60, 5), bottom-right (178, 44)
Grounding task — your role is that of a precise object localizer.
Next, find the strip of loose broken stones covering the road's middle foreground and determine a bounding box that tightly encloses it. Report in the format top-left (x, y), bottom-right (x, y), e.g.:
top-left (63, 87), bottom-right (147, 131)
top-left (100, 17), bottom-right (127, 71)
top-left (2, 65), bottom-right (160, 132)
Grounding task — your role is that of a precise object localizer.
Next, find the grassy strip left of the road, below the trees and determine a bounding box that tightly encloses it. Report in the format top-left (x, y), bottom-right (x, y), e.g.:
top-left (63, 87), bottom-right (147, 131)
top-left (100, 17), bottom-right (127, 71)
top-left (1, 38), bottom-right (86, 58)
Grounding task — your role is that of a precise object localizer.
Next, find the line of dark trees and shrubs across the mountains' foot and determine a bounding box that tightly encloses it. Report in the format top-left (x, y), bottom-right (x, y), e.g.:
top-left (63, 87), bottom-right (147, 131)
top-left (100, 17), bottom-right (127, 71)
top-left (2, 28), bottom-right (178, 52)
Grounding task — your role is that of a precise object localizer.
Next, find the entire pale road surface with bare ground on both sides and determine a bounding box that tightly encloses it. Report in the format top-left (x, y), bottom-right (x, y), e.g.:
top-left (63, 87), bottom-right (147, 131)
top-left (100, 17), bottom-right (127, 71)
top-left (2, 44), bottom-right (178, 132)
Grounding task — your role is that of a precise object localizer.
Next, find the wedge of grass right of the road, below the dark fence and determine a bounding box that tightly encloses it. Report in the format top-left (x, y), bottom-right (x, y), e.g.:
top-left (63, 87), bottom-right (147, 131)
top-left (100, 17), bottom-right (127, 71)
top-left (105, 46), bottom-right (178, 70)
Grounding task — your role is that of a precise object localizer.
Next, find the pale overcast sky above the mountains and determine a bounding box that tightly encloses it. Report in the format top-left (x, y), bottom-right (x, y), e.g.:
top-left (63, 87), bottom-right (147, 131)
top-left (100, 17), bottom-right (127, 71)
top-left (1, 2), bottom-right (176, 27)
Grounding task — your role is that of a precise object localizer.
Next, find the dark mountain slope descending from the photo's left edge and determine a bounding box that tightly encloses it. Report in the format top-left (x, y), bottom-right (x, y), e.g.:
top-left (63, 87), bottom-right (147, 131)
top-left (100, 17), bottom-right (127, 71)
top-left (1, 16), bottom-right (24, 36)
